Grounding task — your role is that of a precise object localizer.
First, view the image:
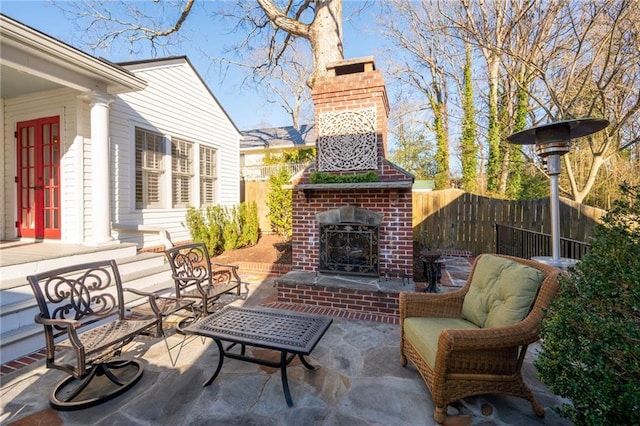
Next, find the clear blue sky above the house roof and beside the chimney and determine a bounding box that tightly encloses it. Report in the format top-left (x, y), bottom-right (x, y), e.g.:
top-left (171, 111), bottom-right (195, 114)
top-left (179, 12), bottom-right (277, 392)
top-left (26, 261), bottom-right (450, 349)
top-left (0, 0), bottom-right (380, 130)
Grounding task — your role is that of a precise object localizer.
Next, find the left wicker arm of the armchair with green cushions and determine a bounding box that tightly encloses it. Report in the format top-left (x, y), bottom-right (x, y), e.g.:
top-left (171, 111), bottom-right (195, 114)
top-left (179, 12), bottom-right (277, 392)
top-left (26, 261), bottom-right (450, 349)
top-left (399, 290), bottom-right (465, 320)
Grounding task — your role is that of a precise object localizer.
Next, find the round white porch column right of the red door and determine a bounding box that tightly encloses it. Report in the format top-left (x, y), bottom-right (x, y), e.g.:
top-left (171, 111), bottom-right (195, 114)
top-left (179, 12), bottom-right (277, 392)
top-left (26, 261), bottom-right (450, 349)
top-left (89, 91), bottom-right (114, 245)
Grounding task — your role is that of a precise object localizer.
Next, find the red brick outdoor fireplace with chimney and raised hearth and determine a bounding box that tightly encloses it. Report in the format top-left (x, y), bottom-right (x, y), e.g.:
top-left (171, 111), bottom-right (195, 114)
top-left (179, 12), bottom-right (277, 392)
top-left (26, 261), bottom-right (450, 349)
top-left (276, 57), bottom-right (413, 314)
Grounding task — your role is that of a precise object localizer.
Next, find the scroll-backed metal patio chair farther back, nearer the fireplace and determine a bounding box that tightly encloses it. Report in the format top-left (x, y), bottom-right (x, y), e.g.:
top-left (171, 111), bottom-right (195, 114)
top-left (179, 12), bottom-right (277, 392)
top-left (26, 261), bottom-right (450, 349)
top-left (165, 243), bottom-right (242, 316)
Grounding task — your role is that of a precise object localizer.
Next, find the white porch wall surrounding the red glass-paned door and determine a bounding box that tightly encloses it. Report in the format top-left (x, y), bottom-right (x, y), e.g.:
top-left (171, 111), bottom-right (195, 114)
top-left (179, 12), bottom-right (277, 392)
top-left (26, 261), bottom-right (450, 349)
top-left (2, 89), bottom-right (83, 243)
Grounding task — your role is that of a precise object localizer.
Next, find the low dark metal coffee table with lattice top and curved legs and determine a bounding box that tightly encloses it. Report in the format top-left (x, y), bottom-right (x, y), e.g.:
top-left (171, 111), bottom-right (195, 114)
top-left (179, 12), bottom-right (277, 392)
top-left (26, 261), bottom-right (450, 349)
top-left (182, 306), bottom-right (333, 407)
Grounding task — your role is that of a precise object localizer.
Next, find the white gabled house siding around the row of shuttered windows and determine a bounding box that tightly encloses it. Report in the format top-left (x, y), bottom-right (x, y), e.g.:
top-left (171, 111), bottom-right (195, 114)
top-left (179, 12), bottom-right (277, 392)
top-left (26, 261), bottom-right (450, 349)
top-left (110, 58), bottom-right (240, 247)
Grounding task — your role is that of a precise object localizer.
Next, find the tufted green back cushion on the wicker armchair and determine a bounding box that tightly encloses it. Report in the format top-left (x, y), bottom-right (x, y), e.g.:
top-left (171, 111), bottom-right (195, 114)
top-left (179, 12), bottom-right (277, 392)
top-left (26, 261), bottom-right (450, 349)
top-left (462, 254), bottom-right (544, 328)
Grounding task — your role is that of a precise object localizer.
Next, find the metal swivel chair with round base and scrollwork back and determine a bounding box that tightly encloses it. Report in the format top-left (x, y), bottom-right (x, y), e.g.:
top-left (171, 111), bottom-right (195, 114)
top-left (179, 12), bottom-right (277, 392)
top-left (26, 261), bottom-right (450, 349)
top-left (27, 260), bottom-right (162, 410)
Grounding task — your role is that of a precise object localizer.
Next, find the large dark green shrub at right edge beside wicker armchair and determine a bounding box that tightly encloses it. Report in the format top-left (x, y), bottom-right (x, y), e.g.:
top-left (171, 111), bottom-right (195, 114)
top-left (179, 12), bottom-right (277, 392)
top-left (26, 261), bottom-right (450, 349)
top-left (536, 187), bottom-right (640, 425)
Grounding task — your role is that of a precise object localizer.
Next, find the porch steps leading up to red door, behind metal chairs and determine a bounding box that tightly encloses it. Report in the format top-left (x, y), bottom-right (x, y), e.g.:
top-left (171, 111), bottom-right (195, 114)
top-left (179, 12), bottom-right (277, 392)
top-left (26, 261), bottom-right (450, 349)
top-left (0, 253), bottom-right (175, 364)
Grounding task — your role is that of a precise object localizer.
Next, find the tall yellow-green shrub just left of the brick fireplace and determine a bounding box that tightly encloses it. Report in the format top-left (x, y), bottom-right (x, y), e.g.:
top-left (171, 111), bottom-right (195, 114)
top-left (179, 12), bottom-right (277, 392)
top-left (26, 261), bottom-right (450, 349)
top-left (267, 167), bottom-right (293, 238)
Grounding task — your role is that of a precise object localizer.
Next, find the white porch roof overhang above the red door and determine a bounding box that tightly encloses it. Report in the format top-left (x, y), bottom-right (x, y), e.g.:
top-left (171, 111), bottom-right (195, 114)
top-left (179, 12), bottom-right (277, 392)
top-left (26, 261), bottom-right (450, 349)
top-left (0, 14), bottom-right (146, 98)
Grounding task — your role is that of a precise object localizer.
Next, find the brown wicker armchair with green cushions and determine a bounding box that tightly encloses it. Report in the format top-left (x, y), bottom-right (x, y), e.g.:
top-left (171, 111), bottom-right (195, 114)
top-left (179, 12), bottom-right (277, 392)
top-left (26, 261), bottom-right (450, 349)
top-left (400, 255), bottom-right (560, 423)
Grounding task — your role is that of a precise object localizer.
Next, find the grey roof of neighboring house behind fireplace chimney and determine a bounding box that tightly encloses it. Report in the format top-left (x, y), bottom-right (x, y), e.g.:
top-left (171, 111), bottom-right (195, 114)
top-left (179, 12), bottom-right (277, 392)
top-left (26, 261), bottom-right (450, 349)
top-left (240, 124), bottom-right (316, 152)
